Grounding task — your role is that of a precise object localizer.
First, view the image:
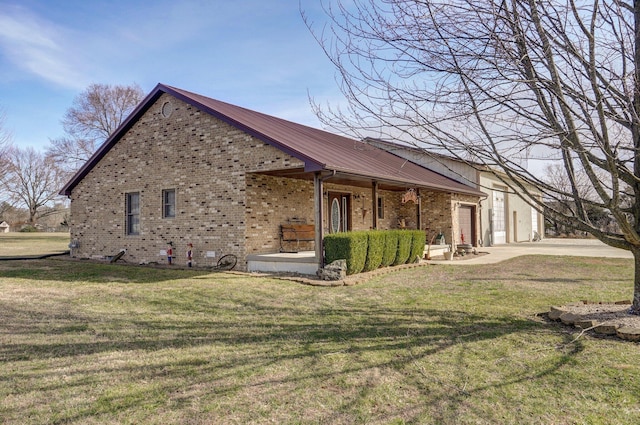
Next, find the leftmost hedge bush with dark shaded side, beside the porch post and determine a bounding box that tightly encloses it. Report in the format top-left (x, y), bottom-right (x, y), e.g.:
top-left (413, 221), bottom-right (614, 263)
top-left (324, 232), bottom-right (368, 274)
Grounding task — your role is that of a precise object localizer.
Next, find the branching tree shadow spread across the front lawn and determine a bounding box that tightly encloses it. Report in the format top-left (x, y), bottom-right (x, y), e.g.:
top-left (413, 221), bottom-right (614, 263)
top-left (0, 299), bottom-right (581, 423)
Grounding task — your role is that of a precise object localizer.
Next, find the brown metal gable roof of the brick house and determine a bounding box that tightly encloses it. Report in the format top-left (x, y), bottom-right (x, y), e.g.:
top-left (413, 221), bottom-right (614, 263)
top-left (60, 84), bottom-right (485, 196)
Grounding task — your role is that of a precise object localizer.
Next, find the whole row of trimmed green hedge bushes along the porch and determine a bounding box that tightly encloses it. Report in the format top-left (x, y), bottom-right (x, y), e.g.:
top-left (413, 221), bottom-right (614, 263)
top-left (324, 230), bottom-right (425, 275)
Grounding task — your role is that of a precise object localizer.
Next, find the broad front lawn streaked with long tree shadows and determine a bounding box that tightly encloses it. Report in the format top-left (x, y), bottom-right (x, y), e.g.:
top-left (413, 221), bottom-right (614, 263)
top-left (0, 247), bottom-right (640, 424)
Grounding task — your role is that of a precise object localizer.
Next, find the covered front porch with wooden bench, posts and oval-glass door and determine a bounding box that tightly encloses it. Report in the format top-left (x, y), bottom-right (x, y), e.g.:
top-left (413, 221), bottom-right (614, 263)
top-left (246, 168), bottom-right (438, 274)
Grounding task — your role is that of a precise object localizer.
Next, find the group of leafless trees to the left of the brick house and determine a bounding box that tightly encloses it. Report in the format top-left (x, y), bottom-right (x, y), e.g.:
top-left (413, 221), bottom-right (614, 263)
top-left (0, 84), bottom-right (144, 228)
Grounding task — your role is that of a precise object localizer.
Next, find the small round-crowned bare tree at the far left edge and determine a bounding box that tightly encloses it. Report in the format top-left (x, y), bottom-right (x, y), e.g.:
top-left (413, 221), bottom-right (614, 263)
top-left (0, 147), bottom-right (61, 225)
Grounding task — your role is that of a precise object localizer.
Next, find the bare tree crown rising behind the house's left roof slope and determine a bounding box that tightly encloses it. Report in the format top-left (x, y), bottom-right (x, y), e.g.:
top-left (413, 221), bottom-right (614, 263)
top-left (47, 84), bottom-right (144, 172)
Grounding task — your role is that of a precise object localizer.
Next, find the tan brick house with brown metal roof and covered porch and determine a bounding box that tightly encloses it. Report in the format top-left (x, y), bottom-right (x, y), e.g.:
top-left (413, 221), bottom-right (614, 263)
top-left (60, 84), bottom-right (485, 270)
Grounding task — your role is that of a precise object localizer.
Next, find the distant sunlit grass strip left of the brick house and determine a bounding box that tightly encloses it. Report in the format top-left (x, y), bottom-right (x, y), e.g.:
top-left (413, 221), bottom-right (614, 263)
top-left (0, 232), bottom-right (69, 258)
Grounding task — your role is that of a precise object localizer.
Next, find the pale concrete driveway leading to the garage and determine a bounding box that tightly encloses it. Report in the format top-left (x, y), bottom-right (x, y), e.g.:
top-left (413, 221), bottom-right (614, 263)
top-left (430, 239), bottom-right (633, 265)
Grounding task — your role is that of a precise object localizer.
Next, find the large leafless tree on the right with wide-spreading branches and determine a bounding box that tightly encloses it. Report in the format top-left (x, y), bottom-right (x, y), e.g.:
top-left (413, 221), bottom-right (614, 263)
top-left (305, 0), bottom-right (640, 314)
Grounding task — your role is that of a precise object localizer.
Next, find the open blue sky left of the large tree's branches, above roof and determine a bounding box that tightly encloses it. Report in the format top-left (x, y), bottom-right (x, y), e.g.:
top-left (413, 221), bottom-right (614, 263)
top-left (0, 0), bottom-right (340, 150)
